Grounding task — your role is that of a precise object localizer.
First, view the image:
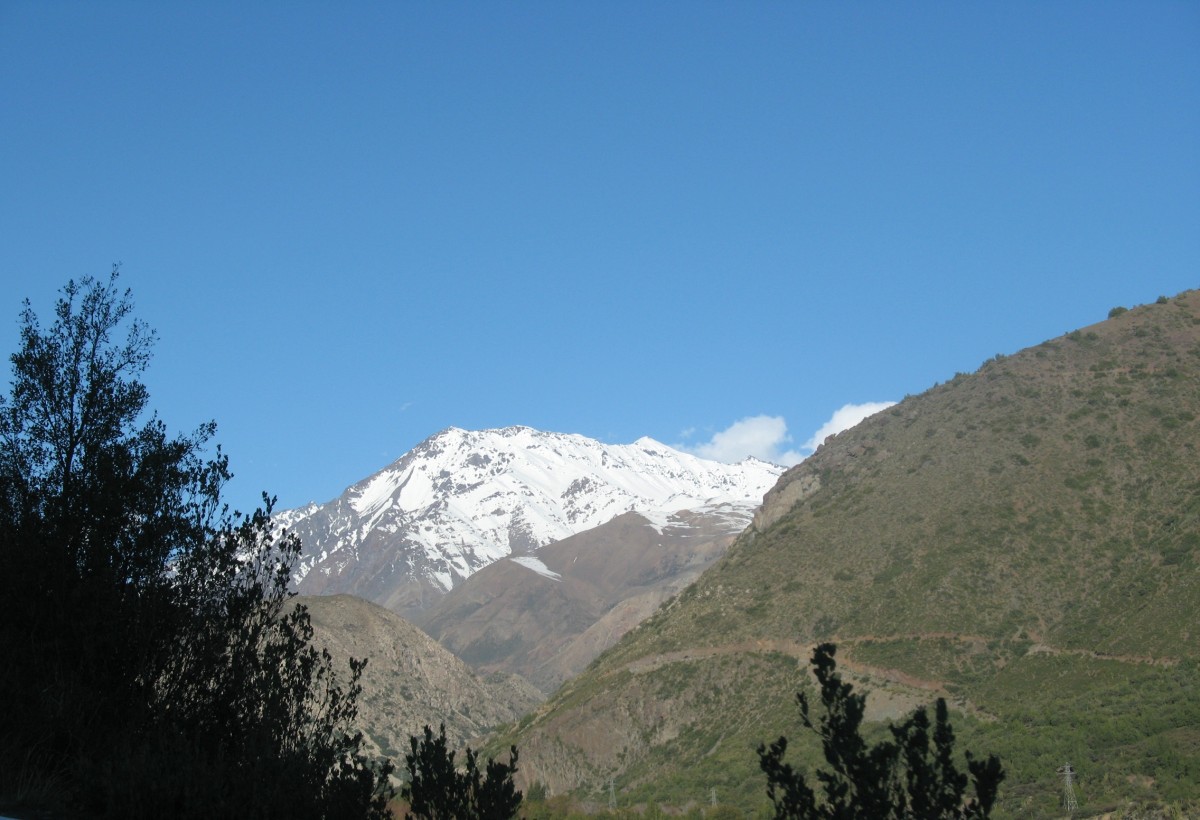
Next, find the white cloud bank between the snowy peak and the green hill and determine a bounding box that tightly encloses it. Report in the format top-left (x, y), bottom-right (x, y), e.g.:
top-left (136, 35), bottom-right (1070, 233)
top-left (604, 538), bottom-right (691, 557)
top-left (674, 401), bottom-right (895, 467)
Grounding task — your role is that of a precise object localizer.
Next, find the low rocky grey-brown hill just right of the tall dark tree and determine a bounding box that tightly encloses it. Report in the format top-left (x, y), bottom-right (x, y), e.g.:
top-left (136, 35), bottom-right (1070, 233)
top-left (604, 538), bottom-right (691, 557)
top-left (296, 595), bottom-right (541, 765)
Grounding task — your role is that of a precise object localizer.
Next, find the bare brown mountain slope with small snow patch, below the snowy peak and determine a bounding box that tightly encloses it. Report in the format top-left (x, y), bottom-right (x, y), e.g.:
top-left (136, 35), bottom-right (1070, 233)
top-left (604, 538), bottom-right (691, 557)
top-left (414, 504), bottom-right (750, 692)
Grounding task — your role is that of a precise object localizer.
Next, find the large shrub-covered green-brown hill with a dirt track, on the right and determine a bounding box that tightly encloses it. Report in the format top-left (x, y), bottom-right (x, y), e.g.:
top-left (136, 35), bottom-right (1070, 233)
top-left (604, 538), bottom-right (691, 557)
top-left (497, 291), bottom-right (1200, 818)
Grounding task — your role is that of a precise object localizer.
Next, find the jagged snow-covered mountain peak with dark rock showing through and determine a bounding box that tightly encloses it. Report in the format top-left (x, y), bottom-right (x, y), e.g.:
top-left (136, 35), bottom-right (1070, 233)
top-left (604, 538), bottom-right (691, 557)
top-left (283, 427), bottom-right (782, 612)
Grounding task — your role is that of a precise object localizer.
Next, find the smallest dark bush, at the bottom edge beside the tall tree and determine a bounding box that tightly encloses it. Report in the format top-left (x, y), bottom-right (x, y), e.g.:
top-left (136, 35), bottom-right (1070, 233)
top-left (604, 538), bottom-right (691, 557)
top-left (401, 724), bottom-right (522, 820)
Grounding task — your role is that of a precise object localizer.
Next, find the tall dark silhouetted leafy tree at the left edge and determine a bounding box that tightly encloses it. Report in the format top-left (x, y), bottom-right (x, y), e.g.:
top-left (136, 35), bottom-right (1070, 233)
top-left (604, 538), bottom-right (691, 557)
top-left (0, 269), bottom-right (390, 819)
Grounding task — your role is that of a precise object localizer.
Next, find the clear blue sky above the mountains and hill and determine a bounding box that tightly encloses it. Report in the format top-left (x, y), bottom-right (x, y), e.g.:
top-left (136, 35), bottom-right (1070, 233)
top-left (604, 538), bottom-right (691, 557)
top-left (0, 0), bottom-right (1200, 509)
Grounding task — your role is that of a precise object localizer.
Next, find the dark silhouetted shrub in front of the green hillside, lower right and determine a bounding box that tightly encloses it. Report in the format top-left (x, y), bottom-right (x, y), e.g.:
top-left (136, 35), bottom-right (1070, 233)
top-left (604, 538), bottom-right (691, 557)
top-left (758, 644), bottom-right (1004, 820)
